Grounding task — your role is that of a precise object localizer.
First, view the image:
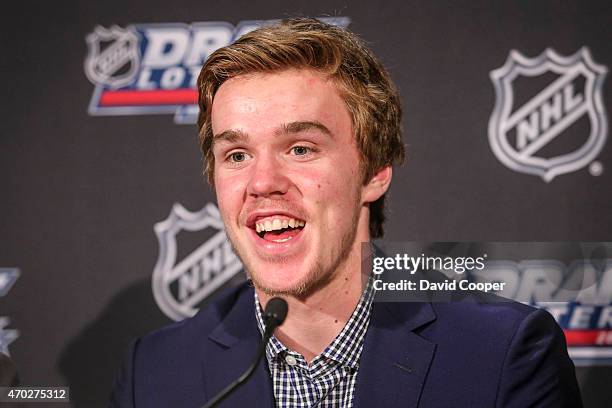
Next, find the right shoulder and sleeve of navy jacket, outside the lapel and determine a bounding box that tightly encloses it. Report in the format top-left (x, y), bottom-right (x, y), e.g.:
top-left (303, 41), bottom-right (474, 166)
top-left (419, 297), bottom-right (582, 407)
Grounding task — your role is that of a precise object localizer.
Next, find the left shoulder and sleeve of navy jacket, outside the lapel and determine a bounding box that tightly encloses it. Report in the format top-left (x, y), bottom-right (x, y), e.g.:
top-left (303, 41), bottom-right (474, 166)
top-left (109, 283), bottom-right (256, 408)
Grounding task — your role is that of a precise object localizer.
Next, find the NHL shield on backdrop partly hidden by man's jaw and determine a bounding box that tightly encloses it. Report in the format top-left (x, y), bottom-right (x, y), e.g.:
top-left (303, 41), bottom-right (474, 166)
top-left (152, 203), bottom-right (242, 321)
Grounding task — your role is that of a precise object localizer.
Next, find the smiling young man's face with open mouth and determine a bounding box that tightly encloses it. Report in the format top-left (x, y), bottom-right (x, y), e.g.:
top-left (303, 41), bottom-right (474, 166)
top-left (212, 69), bottom-right (367, 295)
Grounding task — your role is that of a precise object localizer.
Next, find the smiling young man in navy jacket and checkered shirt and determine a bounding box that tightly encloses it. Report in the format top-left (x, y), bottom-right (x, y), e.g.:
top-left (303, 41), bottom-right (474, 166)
top-left (112, 19), bottom-right (581, 407)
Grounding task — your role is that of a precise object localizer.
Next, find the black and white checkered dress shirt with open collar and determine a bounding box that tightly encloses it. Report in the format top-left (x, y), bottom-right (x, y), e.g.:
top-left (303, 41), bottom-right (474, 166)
top-left (255, 279), bottom-right (374, 408)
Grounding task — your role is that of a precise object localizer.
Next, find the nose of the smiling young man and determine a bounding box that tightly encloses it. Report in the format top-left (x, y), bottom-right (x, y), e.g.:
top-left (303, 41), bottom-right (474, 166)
top-left (247, 154), bottom-right (290, 197)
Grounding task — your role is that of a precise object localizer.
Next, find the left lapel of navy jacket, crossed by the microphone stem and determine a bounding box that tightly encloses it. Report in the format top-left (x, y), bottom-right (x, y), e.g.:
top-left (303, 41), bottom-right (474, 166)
top-left (202, 288), bottom-right (274, 407)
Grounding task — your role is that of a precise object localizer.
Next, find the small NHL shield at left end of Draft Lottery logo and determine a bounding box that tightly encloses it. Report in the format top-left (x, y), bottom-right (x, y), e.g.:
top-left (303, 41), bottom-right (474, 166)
top-left (85, 26), bottom-right (140, 88)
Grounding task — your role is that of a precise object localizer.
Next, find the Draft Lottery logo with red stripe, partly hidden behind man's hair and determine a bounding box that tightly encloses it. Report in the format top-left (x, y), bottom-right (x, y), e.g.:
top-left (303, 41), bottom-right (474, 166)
top-left (85, 17), bottom-right (350, 124)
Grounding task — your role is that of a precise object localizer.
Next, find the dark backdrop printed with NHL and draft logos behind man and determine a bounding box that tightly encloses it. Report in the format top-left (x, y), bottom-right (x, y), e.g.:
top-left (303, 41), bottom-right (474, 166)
top-left (0, 0), bottom-right (612, 407)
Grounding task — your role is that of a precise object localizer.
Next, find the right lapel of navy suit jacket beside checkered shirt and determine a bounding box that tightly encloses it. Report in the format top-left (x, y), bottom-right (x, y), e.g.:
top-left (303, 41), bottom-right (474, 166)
top-left (353, 300), bottom-right (436, 408)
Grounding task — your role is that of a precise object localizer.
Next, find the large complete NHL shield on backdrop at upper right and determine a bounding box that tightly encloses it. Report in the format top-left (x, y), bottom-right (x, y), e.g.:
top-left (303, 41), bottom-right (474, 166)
top-left (489, 47), bottom-right (608, 182)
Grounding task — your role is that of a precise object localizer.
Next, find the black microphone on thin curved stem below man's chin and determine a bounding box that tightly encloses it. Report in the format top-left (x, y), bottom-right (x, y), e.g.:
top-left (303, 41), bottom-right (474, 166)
top-left (202, 298), bottom-right (289, 408)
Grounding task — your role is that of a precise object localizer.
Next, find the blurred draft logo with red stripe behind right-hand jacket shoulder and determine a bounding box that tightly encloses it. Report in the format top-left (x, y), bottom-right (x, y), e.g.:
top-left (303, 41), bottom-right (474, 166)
top-left (481, 259), bottom-right (612, 366)
